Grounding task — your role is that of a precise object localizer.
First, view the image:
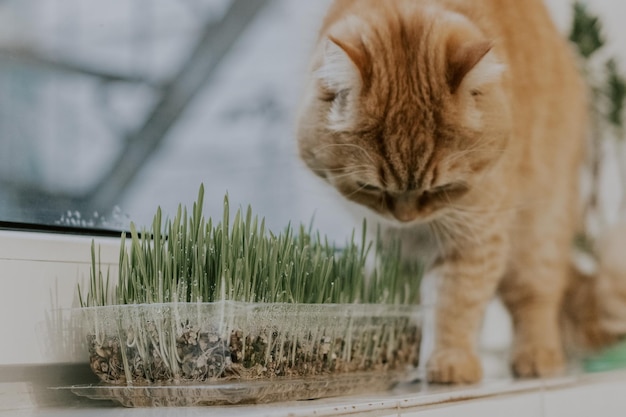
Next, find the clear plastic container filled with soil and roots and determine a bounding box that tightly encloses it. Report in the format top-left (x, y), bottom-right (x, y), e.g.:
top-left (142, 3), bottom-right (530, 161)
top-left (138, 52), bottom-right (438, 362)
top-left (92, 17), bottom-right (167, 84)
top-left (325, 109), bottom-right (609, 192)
top-left (72, 302), bottom-right (421, 407)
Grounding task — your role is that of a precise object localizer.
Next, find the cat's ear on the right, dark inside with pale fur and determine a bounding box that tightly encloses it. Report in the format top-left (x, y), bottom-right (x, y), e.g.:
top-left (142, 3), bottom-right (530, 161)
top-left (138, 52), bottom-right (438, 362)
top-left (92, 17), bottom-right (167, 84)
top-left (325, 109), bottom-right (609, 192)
top-left (446, 41), bottom-right (504, 94)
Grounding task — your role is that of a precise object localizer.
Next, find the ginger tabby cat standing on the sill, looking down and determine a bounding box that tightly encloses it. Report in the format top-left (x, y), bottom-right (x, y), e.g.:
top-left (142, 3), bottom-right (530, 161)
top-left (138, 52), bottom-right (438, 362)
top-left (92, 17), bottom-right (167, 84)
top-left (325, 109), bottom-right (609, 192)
top-left (297, 0), bottom-right (624, 383)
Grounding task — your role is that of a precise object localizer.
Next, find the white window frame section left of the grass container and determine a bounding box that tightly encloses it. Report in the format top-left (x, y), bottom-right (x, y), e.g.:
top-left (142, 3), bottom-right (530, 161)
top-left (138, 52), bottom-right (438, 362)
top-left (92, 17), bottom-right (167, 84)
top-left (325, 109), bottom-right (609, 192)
top-left (0, 231), bottom-right (119, 367)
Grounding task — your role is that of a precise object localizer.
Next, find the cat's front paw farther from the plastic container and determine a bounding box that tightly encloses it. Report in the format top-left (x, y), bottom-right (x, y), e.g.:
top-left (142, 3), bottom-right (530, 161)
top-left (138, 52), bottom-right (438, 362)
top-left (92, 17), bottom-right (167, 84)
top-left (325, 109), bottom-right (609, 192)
top-left (513, 344), bottom-right (564, 378)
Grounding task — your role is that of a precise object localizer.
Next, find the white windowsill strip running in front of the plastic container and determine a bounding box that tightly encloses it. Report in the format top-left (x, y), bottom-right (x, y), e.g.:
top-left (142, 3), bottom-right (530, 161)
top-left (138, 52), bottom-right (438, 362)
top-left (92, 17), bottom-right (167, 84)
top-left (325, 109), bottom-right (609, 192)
top-left (0, 372), bottom-right (626, 417)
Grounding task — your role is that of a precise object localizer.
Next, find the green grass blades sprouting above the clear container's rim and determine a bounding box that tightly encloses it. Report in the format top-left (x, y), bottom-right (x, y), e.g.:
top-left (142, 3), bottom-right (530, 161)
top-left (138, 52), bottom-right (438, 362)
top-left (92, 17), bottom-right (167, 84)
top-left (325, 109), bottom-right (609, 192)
top-left (78, 186), bottom-right (422, 307)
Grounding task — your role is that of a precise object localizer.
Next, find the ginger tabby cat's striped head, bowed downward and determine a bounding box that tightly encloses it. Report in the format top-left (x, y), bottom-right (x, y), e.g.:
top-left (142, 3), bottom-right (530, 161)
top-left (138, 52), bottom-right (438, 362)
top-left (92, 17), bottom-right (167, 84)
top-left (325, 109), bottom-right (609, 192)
top-left (298, 2), bottom-right (510, 223)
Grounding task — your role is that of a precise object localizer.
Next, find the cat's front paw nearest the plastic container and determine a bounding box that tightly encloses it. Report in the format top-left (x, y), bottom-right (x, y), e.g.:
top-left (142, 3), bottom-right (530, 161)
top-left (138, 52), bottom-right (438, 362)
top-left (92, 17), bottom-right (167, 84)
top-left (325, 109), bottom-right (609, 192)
top-left (427, 348), bottom-right (483, 384)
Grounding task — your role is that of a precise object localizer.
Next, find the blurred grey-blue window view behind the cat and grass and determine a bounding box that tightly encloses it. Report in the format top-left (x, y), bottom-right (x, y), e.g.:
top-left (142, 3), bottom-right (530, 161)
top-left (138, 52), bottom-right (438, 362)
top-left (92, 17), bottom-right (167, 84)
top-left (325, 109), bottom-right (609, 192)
top-left (0, 0), bottom-right (626, 240)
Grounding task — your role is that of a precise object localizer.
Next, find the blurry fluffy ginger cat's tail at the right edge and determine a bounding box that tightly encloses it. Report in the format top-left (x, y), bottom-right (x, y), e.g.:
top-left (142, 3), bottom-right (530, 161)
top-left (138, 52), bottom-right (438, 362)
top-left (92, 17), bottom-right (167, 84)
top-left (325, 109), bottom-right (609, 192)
top-left (563, 221), bottom-right (626, 351)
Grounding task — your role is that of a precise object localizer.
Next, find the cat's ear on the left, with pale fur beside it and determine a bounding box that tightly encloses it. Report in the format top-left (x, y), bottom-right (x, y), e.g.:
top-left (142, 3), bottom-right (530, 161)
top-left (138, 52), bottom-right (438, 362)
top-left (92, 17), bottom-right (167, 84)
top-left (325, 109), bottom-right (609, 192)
top-left (316, 19), bottom-right (371, 93)
